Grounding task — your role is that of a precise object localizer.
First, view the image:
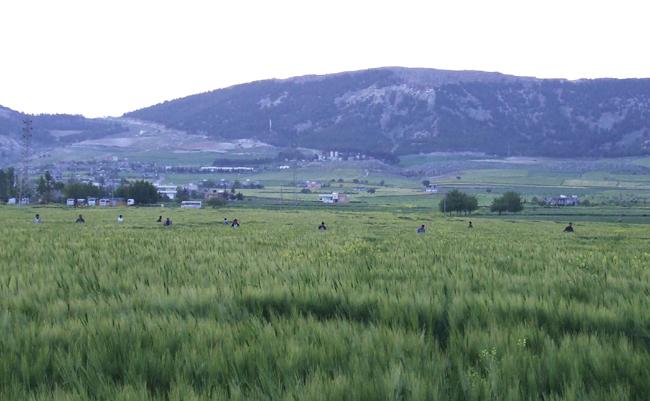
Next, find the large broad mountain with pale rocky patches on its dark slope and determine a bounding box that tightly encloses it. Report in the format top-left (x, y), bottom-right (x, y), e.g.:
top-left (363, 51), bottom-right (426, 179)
top-left (125, 67), bottom-right (650, 157)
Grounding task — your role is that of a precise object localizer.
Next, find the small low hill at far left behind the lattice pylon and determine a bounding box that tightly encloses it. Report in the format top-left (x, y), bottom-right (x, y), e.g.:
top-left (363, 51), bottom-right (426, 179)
top-left (0, 106), bottom-right (125, 165)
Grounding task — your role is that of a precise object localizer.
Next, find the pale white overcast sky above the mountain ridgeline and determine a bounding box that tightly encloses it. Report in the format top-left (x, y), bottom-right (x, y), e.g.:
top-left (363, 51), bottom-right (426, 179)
top-left (0, 0), bottom-right (650, 117)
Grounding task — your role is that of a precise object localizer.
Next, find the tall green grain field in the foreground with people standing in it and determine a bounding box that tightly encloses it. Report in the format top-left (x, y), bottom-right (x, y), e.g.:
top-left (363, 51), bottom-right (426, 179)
top-left (0, 207), bottom-right (650, 401)
